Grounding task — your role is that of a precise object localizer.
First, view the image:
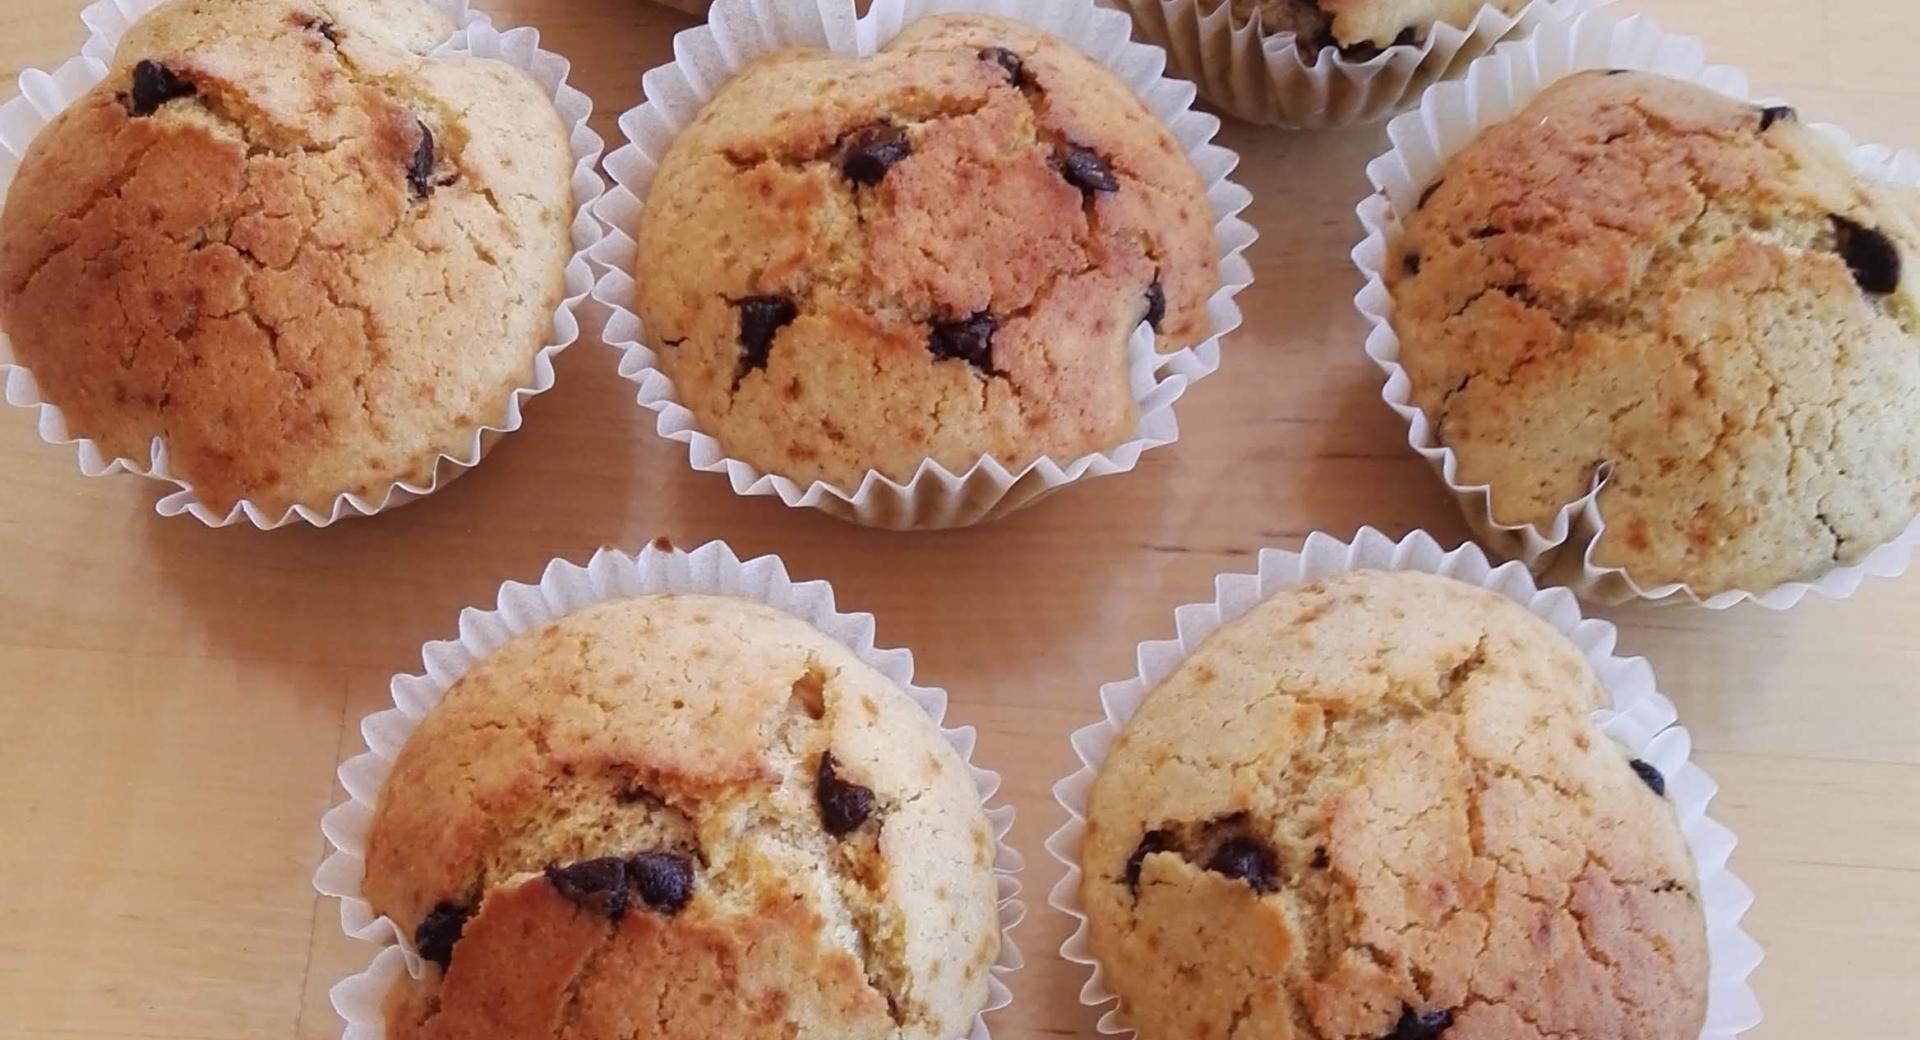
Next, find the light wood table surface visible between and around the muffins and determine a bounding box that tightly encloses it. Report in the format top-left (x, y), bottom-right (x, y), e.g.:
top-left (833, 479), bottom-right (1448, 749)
top-left (0, 0), bottom-right (1920, 1040)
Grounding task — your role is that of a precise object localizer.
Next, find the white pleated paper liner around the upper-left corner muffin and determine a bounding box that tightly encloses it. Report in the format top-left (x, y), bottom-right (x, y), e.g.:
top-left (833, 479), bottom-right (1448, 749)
top-left (0, 0), bottom-right (607, 530)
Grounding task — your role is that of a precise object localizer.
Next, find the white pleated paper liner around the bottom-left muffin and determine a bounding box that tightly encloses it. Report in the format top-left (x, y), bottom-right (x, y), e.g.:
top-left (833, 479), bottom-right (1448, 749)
top-left (313, 541), bottom-right (1025, 1040)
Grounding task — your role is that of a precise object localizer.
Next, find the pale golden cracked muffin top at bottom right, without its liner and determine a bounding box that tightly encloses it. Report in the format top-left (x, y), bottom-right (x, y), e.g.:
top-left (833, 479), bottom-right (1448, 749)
top-left (1081, 572), bottom-right (1707, 1040)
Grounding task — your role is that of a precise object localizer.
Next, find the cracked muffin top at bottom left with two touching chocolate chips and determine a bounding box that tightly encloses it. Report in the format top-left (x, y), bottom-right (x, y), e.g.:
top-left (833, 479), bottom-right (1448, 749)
top-left (363, 595), bottom-right (1000, 1040)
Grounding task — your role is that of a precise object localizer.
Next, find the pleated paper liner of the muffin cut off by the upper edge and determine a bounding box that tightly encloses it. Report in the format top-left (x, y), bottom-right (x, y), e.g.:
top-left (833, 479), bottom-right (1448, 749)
top-left (1102, 0), bottom-right (1613, 130)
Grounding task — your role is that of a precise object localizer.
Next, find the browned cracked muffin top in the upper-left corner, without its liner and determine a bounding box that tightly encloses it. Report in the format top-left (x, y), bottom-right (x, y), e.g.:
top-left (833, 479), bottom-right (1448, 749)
top-left (0, 0), bottom-right (574, 514)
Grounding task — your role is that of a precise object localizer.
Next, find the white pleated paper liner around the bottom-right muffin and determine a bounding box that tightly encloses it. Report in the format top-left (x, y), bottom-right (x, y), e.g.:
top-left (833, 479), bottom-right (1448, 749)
top-left (1046, 528), bottom-right (1761, 1040)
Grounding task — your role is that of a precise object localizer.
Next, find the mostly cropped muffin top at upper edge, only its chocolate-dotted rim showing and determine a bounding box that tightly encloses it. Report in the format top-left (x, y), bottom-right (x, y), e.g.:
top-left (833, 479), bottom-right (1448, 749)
top-left (1200, 0), bottom-right (1530, 58)
